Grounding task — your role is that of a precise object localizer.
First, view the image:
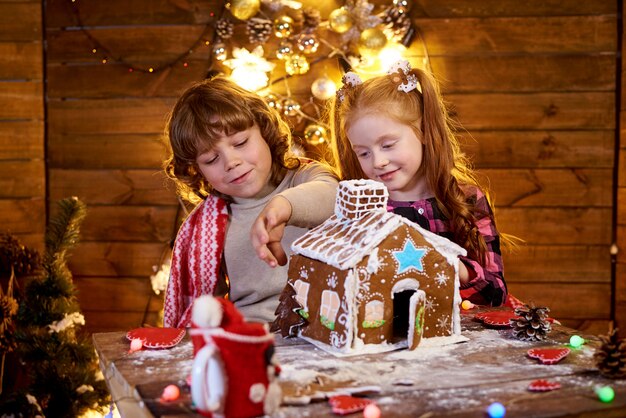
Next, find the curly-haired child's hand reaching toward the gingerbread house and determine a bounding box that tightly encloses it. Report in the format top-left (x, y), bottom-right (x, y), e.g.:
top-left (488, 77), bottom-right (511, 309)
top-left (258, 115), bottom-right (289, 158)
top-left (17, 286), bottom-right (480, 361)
top-left (250, 196), bottom-right (291, 267)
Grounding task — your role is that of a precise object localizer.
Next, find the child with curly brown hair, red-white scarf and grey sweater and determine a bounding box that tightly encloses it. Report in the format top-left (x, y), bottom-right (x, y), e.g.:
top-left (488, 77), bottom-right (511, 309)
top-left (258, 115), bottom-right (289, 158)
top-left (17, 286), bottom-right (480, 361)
top-left (164, 78), bottom-right (337, 327)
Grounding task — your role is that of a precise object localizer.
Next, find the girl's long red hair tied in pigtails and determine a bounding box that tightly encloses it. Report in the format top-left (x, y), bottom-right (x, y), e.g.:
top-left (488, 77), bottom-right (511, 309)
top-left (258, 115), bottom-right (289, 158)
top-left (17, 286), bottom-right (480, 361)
top-left (331, 69), bottom-right (495, 264)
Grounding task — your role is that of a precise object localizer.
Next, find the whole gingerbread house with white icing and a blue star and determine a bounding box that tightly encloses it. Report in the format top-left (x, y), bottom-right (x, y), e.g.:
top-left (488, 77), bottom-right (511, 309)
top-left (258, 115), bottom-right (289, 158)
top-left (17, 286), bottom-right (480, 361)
top-left (274, 180), bottom-right (466, 354)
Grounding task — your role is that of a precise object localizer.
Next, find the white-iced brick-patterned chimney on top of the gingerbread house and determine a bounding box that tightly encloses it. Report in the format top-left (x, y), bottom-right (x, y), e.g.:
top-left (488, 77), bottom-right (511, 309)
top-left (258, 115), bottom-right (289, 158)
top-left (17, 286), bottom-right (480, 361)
top-left (335, 180), bottom-right (389, 219)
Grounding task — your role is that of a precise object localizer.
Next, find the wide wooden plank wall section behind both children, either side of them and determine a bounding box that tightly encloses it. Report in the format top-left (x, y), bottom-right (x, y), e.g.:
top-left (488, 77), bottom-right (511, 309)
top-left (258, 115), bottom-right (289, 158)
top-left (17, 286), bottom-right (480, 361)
top-left (41, 0), bottom-right (618, 332)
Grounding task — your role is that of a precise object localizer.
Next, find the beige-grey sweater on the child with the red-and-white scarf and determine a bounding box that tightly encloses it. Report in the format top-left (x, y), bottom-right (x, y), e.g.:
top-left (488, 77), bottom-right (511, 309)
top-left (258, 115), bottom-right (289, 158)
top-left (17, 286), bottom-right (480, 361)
top-left (224, 162), bottom-right (337, 322)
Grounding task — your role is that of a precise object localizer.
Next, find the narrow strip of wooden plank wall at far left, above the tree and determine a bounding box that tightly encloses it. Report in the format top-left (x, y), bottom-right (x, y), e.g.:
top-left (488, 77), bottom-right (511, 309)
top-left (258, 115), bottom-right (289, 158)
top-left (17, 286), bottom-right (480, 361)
top-left (0, 0), bottom-right (46, 250)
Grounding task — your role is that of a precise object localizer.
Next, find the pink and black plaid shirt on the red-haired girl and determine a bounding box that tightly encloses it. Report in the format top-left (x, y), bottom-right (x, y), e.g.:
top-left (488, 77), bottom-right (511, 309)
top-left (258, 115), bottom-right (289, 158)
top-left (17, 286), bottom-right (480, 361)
top-left (387, 186), bottom-right (507, 306)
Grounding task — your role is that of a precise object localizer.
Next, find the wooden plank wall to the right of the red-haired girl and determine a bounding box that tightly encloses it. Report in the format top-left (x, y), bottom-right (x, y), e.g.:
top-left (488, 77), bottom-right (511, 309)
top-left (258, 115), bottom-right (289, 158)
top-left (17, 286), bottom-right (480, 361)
top-left (404, 0), bottom-right (618, 333)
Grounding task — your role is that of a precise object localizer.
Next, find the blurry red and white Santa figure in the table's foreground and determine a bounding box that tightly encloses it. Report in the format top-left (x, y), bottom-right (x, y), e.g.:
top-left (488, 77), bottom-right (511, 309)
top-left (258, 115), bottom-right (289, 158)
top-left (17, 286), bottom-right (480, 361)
top-left (190, 295), bottom-right (281, 418)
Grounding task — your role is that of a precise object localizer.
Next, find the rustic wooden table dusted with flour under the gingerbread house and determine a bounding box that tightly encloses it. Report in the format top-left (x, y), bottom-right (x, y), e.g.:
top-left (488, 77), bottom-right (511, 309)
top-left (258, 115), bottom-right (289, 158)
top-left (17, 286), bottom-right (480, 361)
top-left (93, 311), bottom-right (626, 418)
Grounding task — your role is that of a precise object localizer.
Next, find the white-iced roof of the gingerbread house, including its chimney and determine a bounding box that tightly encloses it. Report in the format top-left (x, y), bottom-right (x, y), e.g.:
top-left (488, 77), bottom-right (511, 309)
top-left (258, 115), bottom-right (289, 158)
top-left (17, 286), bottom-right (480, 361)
top-left (291, 180), bottom-right (466, 270)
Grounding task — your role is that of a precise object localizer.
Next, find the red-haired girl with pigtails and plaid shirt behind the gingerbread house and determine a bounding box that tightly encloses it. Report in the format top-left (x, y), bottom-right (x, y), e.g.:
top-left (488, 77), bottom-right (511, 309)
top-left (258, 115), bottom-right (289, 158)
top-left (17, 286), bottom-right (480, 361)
top-left (332, 61), bottom-right (507, 306)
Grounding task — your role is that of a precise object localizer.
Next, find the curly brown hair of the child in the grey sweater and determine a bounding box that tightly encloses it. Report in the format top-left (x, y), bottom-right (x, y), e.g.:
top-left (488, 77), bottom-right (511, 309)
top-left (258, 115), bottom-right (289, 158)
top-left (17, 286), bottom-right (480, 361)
top-left (164, 77), bottom-right (300, 202)
